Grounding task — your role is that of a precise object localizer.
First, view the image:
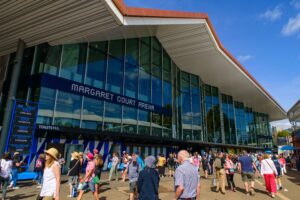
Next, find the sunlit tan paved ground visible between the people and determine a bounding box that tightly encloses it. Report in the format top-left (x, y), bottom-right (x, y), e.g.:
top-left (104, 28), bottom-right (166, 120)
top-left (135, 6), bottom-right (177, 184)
top-left (2, 171), bottom-right (300, 200)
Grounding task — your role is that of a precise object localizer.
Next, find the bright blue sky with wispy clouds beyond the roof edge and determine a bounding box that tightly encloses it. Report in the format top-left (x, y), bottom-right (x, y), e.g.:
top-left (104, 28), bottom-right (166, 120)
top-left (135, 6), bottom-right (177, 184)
top-left (125, 0), bottom-right (300, 128)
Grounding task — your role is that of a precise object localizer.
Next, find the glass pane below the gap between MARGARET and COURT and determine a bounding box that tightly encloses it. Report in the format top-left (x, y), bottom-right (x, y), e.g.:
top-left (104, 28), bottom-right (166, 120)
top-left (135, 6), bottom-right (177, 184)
top-left (104, 102), bottom-right (122, 132)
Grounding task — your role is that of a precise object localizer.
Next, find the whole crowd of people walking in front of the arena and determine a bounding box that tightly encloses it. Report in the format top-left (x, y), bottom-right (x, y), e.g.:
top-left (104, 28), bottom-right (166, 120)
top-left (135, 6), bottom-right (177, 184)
top-left (0, 148), bottom-right (298, 200)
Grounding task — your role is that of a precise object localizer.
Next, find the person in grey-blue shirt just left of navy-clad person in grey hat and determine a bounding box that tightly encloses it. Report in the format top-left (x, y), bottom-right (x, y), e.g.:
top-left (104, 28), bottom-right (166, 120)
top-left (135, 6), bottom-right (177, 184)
top-left (128, 155), bottom-right (141, 200)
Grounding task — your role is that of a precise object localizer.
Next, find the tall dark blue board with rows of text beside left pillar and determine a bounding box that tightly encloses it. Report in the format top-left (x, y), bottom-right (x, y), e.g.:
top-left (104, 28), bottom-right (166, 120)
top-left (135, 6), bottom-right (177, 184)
top-left (6, 100), bottom-right (38, 158)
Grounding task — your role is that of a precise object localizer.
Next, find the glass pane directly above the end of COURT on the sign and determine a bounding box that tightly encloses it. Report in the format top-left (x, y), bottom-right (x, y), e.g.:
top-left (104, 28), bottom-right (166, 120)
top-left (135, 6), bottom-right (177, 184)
top-left (125, 64), bottom-right (139, 99)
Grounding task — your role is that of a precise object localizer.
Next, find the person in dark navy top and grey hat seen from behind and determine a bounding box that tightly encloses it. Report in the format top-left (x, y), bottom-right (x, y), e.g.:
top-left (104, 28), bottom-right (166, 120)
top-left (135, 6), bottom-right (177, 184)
top-left (137, 156), bottom-right (159, 200)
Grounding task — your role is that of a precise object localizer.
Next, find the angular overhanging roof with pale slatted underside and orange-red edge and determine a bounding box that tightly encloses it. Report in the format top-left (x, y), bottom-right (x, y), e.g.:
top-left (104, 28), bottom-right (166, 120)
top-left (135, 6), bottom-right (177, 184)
top-left (0, 0), bottom-right (286, 120)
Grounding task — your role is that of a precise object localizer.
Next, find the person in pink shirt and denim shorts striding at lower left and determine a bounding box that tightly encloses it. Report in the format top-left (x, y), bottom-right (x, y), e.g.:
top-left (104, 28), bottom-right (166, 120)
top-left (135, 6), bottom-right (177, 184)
top-left (77, 152), bottom-right (98, 200)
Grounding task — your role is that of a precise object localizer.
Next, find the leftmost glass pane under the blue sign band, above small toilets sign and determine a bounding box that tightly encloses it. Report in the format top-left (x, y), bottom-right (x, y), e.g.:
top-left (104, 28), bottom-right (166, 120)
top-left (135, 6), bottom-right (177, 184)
top-left (36, 87), bottom-right (56, 125)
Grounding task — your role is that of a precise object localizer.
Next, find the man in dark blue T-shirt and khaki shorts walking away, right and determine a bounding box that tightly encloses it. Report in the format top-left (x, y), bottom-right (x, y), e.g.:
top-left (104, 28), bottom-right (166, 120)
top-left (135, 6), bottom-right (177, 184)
top-left (238, 150), bottom-right (257, 195)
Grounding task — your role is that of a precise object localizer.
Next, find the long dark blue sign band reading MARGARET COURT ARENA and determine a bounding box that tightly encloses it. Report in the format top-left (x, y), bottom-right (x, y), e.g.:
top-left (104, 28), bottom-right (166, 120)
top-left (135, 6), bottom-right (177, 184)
top-left (33, 74), bottom-right (172, 115)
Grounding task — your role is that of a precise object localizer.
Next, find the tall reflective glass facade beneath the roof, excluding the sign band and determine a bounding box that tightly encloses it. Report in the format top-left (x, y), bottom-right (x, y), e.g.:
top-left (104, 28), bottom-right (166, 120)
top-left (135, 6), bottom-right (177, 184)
top-left (0, 37), bottom-right (271, 146)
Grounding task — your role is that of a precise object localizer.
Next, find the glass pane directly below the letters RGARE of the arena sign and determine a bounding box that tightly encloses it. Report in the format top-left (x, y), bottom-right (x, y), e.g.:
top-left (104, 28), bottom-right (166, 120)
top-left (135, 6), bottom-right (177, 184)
top-left (81, 97), bottom-right (103, 130)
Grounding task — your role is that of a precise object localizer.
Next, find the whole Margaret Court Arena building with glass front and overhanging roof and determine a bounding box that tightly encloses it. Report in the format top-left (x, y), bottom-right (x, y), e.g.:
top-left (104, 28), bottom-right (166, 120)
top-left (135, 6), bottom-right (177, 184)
top-left (0, 0), bottom-right (286, 172)
